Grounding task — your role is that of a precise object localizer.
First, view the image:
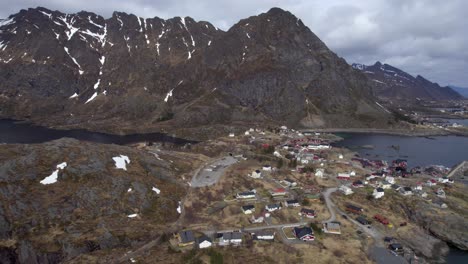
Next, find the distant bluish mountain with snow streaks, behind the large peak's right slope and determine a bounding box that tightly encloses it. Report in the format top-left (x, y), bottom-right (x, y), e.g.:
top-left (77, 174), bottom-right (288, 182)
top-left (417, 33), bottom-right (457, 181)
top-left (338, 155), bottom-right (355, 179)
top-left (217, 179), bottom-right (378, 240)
top-left (352, 62), bottom-right (463, 101)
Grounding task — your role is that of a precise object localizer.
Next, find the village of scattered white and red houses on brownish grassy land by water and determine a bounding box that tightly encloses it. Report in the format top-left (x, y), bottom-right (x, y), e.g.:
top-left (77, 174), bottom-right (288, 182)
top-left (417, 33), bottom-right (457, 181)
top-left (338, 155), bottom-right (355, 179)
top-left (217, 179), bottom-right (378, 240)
top-left (156, 126), bottom-right (464, 263)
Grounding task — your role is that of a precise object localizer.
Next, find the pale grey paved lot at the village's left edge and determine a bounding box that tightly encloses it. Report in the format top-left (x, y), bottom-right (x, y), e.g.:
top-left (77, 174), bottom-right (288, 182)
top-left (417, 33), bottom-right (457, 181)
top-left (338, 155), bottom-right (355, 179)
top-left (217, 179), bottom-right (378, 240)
top-left (190, 156), bottom-right (238, 188)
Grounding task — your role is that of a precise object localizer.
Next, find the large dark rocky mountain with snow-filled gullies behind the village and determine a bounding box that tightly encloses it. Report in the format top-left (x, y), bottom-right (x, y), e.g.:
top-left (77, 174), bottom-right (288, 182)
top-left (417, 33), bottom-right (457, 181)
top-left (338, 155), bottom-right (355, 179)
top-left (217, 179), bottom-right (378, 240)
top-left (0, 7), bottom-right (393, 132)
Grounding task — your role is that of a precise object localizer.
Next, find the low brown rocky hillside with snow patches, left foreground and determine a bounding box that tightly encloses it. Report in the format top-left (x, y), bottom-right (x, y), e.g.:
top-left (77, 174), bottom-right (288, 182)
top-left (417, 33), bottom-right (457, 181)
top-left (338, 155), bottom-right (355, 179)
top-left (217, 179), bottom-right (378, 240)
top-left (0, 139), bottom-right (185, 263)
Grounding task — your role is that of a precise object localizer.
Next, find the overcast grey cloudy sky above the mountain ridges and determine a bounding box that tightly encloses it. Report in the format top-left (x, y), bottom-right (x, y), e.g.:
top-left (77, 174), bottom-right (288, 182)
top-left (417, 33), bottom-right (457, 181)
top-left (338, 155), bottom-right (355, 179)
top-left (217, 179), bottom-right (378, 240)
top-left (0, 0), bottom-right (468, 87)
